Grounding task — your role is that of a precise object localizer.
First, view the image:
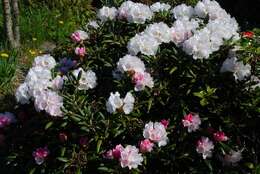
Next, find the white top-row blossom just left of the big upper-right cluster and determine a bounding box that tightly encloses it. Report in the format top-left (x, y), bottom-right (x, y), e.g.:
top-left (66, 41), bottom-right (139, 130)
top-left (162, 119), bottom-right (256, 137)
top-left (172, 4), bottom-right (194, 19)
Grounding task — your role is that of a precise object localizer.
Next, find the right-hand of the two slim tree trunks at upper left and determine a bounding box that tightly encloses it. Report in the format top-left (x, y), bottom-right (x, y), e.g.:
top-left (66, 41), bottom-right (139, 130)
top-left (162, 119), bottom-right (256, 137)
top-left (12, 0), bottom-right (20, 47)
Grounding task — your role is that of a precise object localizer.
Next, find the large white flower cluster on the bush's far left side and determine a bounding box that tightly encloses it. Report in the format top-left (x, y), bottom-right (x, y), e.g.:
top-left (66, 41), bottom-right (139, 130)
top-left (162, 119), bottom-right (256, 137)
top-left (15, 55), bottom-right (63, 116)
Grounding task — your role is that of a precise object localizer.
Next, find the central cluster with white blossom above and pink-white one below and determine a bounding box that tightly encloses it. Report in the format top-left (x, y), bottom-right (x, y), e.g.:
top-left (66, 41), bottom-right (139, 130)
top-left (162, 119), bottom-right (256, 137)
top-left (117, 55), bottom-right (154, 91)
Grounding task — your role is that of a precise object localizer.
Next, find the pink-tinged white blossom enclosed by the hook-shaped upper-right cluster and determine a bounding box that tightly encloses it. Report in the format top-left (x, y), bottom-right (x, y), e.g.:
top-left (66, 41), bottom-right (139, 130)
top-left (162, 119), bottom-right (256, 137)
top-left (170, 19), bottom-right (200, 46)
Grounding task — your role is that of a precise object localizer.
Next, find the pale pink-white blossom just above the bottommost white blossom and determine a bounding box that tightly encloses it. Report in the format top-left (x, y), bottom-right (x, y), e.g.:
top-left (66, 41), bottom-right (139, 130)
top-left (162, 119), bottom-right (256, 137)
top-left (143, 122), bottom-right (168, 147)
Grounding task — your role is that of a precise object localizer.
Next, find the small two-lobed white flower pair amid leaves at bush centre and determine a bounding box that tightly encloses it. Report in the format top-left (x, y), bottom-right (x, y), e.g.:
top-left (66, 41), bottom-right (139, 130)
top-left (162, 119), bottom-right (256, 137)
top-left (106, 92), bottom-right (135, 114)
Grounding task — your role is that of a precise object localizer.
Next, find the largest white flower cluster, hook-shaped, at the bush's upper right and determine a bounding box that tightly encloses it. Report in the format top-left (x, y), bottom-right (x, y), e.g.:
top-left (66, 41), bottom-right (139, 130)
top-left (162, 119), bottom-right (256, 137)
top-left (180, 0), bottom-right (239, 59)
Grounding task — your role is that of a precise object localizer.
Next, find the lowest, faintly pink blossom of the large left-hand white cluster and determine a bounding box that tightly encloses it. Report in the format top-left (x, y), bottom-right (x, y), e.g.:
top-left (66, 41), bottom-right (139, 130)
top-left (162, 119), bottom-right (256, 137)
top-left (34, 90), bottom-right (63, 117)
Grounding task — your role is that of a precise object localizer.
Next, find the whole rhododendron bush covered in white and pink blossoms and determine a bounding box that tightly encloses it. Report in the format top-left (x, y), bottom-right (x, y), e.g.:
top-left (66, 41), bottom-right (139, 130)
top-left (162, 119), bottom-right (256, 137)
top-left (0, 0), bottom-right (260, 173)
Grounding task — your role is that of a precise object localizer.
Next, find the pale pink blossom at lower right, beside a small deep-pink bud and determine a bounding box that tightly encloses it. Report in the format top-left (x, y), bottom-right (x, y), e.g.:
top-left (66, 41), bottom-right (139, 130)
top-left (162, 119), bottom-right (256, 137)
top-left (196, 137), bottom-right (214, 159)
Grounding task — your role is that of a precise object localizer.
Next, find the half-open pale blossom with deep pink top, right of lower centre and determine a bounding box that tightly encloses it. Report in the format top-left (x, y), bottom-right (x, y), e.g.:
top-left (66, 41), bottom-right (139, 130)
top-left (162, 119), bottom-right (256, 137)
top-left (182, 113), bottom-right (201, 132)
